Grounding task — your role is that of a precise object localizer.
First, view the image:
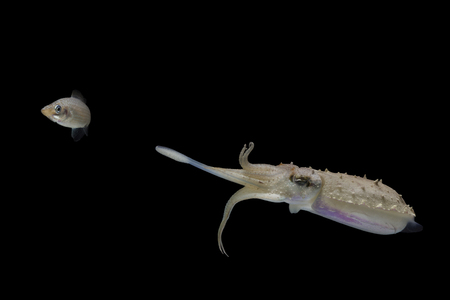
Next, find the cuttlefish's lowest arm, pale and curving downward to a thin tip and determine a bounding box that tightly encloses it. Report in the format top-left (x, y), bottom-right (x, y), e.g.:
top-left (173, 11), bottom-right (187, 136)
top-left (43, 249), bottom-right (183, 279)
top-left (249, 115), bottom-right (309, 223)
top-left (217, 186), bottom-right (283, 256)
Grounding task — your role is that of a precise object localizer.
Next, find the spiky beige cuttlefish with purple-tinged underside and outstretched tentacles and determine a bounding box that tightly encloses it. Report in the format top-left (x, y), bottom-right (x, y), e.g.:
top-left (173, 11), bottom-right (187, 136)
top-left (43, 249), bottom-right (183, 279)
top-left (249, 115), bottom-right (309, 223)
top-left (156, 143), bottom-right (422, 255)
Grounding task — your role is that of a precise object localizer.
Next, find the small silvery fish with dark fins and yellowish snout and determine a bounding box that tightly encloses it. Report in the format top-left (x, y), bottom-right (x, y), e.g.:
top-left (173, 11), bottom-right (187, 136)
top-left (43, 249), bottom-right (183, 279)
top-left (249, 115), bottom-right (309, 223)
top-left (41, 90), bottom-right (91, 142)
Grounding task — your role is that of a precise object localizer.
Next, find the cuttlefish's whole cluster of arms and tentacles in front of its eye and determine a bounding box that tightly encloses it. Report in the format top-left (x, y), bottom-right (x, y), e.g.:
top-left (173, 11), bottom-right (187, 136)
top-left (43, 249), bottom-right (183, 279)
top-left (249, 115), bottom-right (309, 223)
top-left (156, 143), bottom-right (286, 256)
